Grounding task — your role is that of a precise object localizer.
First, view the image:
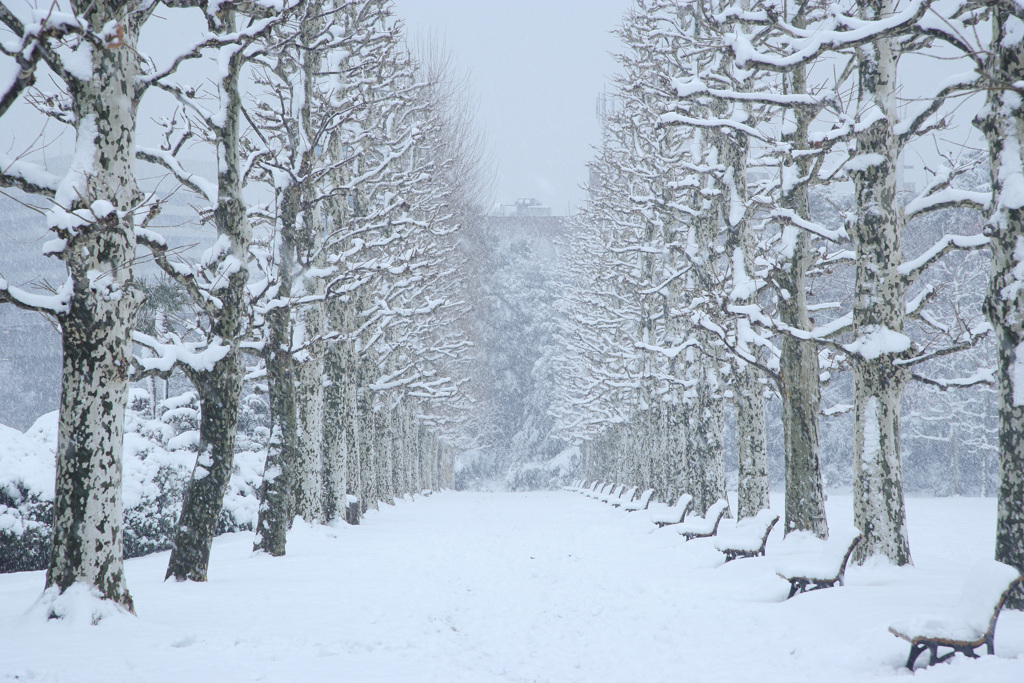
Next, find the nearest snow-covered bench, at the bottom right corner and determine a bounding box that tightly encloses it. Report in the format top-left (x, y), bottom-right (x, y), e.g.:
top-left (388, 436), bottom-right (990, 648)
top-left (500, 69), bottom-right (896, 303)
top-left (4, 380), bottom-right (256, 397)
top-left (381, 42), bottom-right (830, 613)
top-left (889, 560), bottom-right (1022, 671)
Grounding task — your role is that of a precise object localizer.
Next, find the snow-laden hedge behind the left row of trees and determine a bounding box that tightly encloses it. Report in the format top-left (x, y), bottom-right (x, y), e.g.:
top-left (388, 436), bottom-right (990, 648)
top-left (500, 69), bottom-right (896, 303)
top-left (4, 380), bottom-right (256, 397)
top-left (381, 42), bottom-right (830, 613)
top-left (0, 388), bottom-right (267, 572)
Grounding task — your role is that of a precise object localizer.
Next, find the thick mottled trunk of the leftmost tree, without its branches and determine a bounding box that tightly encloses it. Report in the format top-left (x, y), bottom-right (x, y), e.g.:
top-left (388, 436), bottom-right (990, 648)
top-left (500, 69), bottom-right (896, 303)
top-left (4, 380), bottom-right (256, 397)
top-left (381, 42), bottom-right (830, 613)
top-left (46, 0), bottom-right (147, 610)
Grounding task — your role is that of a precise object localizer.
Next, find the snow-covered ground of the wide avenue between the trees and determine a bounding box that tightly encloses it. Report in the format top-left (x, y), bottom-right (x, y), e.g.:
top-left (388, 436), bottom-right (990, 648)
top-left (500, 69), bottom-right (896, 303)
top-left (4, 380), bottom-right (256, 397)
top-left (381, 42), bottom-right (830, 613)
top-left (0, 492), bottom-right (1024, 683)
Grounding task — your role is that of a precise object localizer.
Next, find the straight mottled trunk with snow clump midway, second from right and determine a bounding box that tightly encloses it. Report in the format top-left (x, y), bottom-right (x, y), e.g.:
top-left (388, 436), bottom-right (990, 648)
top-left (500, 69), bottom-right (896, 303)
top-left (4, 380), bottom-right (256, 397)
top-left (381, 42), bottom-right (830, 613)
top-left (848, 0), bottom-right (911, 565)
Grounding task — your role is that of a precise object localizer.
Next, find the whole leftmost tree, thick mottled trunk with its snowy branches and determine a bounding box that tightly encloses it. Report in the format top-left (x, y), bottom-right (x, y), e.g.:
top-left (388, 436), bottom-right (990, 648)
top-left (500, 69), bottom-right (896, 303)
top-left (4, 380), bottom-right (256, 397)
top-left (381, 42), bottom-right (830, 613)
top-left (0, 0), bottom-right (152, 610)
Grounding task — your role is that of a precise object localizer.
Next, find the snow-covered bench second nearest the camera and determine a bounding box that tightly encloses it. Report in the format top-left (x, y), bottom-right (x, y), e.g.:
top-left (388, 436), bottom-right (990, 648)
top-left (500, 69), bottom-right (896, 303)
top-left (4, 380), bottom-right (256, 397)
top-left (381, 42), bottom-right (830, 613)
top-left (775, 528), bottom-right (861, 600)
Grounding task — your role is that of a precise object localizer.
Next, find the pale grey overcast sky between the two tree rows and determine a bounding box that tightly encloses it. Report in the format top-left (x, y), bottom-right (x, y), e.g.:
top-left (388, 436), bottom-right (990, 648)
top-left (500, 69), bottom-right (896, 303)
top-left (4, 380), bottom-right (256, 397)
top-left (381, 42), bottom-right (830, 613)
top-left (394, 0), bottom-right (633, 215)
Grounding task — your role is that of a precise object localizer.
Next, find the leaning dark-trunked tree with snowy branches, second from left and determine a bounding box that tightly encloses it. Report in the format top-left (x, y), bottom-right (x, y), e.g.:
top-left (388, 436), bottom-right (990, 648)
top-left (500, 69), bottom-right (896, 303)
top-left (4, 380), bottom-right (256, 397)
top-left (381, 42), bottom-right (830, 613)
top-left (134, 0), bottom-right (299, 582)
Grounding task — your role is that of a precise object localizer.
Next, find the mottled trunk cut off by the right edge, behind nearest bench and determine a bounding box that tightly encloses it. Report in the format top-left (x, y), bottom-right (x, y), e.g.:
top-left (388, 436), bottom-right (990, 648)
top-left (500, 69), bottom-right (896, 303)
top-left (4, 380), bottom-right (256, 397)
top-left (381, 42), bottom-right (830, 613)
top-left (975, 0), bottom-right (1024, 609)
